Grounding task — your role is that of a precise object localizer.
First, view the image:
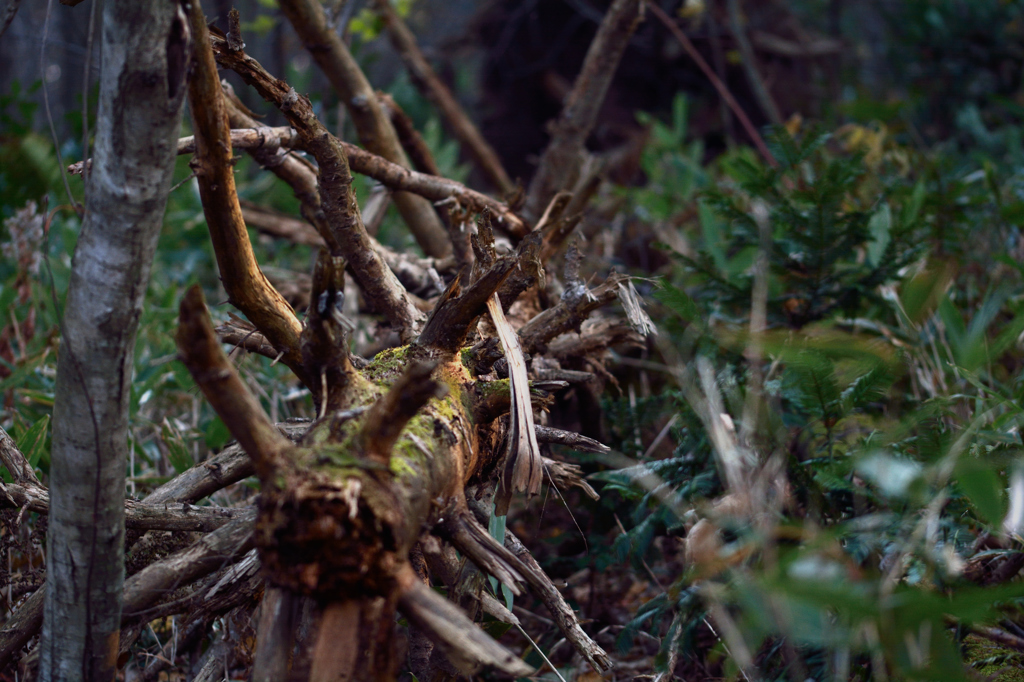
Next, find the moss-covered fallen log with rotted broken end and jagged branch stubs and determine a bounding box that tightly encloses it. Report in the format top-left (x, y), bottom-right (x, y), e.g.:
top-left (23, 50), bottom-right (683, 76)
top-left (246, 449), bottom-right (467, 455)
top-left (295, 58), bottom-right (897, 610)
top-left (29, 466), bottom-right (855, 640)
top-left (159, 3), bottom-right (647, 679)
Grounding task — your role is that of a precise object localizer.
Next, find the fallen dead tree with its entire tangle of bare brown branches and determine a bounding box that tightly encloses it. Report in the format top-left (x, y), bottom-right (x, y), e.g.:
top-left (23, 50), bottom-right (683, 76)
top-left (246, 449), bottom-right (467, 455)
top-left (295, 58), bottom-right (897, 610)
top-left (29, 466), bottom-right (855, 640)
top-left (0, 0), bottom-right (650, 680)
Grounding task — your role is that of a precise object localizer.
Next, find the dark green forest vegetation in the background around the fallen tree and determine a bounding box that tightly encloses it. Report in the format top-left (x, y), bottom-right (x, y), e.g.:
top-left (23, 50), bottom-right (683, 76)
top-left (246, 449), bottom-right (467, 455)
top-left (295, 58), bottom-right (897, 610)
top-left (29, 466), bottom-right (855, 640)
top-left (6, 0), bottom-right (1024, 680)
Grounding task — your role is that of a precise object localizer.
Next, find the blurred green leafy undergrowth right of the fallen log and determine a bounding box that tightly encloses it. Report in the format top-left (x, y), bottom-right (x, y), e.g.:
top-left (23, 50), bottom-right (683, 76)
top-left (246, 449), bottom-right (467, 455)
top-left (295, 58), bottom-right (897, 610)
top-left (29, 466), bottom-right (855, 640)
top-left (592, 80), bottom-right (1024, 680)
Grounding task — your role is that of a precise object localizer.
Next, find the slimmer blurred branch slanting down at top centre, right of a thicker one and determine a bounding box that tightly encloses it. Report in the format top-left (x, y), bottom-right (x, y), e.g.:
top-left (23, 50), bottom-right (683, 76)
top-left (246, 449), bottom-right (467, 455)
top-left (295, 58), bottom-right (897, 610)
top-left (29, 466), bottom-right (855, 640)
top-left (375, 0), bottom-right (516, 197)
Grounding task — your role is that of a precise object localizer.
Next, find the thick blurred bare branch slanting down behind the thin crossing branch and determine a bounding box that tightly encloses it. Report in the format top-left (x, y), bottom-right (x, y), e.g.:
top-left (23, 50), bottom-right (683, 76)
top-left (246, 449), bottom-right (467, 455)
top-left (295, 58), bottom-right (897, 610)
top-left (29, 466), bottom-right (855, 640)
top-left (281, 0), bottom-right (451, 258)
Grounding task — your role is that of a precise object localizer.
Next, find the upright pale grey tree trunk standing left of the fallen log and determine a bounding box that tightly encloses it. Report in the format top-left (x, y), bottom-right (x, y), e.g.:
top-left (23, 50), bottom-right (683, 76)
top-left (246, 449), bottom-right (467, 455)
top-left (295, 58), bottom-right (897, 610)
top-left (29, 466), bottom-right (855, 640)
top-left (40, 0), bottom-right (190, 680)
